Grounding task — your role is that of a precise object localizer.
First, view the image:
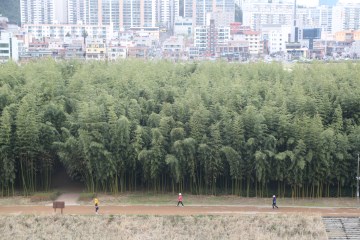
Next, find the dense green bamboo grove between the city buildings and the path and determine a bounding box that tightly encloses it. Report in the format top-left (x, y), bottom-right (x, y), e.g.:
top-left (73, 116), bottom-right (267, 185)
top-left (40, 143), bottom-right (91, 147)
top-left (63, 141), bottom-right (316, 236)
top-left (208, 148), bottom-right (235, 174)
top-left (0, 60), bottom-right (360, 197)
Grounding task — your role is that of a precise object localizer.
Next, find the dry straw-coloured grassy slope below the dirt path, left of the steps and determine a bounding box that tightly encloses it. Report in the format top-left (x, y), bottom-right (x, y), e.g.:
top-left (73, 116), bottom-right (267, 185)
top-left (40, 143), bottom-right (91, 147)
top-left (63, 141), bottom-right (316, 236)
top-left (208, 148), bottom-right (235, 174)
top-left (0, 215), bottom-right (326, 240)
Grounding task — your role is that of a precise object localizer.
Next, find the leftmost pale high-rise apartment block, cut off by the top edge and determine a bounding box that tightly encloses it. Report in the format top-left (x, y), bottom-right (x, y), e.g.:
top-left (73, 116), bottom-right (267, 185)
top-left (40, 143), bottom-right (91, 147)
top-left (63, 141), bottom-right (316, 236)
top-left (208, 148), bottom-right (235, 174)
top-left (20, 0), bottom-right (55, 24)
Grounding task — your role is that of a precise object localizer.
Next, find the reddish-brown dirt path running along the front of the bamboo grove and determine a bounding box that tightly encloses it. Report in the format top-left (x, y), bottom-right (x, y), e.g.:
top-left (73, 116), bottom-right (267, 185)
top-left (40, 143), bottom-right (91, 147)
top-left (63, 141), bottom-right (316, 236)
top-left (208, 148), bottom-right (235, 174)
top-left (0, 205), bottom-right (360, 217)
